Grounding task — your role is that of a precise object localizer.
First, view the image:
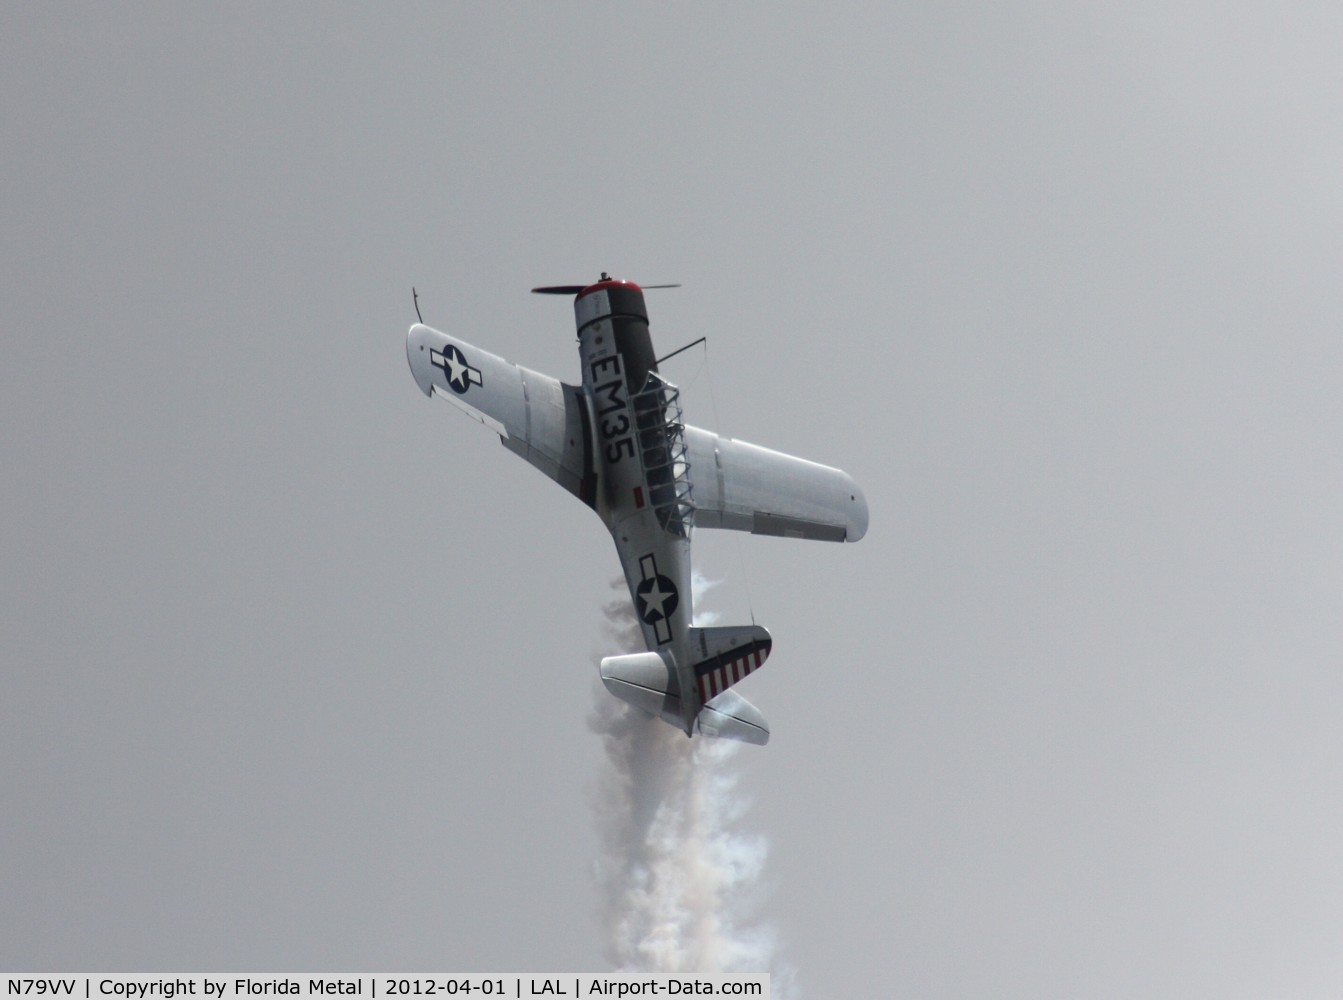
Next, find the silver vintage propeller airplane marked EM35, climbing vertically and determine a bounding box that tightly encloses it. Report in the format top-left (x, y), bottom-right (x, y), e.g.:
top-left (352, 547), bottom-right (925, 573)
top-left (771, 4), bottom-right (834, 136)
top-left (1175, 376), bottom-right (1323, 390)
top-left (406, 272), bottom-right (868, 746)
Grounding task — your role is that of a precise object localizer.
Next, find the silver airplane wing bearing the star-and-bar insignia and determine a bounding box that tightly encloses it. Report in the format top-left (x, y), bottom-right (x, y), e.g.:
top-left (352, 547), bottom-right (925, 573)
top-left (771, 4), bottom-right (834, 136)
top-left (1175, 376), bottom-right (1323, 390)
top-left (406, 323), bottom-right (596, 506)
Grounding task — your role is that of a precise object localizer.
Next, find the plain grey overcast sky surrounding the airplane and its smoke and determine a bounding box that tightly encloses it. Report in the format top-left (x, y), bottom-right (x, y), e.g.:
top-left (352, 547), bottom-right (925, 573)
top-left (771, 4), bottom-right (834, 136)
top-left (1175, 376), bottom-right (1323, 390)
top-left (0, 3), bottom-right (1343, 997)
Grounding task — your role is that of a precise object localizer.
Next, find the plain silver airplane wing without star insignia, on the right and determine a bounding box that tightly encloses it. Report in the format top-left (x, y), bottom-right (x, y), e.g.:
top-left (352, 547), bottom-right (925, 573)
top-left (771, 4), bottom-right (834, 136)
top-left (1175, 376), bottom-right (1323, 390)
top-left (685, 427), bottom-right (868, 542)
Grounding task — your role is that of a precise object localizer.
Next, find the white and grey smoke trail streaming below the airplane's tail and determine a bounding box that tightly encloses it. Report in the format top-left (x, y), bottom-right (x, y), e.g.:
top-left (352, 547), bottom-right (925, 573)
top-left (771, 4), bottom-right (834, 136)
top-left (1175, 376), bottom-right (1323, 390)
top-left (588, 576), bottom-right (791, 997)
